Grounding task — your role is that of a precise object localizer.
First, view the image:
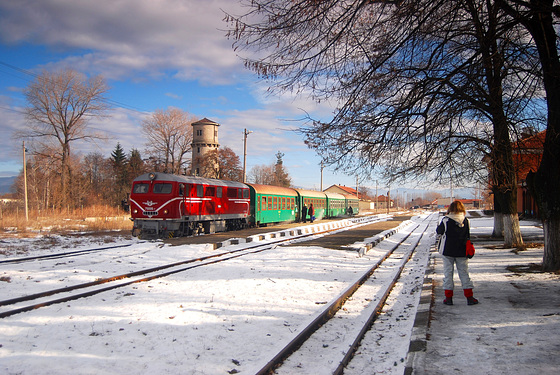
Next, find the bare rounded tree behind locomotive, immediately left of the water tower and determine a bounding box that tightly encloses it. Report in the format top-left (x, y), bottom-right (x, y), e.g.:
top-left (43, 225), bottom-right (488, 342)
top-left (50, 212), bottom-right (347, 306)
top-left (142, 108), bottom-right (197, 174)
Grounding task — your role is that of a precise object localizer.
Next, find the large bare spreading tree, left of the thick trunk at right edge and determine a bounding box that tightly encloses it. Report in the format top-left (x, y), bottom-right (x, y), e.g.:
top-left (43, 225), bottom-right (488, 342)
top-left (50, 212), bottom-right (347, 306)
top-left (226, 0), bottom-right (538, 250)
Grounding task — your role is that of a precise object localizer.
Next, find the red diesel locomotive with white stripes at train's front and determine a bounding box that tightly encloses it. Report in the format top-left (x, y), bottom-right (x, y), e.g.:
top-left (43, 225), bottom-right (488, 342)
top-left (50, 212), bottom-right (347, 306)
top-left (130, 173), bottom-right (250, 238)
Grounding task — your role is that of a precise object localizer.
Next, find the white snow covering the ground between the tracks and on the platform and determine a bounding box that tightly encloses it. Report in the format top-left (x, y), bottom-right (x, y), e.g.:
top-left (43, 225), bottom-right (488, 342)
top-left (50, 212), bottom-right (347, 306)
top-left (0, 214), bottom-right (560, 375)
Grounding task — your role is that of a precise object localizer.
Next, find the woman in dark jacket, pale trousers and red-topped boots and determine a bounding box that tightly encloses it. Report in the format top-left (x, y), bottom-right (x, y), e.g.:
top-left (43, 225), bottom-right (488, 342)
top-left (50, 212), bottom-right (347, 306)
top-left (436, 201), bottom-right (478, 305)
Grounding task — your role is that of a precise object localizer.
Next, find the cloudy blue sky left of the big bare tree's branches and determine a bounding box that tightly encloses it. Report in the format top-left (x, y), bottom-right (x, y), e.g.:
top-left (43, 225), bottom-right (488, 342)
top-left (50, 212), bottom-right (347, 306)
top-left (0, 0), bottom-right (466, 200)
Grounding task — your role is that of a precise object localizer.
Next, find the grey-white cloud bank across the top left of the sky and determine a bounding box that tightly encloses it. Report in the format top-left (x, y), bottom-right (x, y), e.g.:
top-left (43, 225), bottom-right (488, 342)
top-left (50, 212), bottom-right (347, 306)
top-left (0, 0), bottom-right (243, 84)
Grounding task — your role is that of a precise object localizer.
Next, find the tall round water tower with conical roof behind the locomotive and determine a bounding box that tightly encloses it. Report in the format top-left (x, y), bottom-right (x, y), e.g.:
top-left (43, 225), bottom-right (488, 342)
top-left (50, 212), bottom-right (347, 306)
top-left (191, 118), bottom-right (220, 177)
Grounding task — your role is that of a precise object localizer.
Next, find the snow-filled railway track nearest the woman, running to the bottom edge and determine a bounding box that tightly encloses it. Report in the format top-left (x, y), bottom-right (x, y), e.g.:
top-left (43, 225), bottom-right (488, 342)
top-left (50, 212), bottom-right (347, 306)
top-left (256, 215), bottom-right (437, 375)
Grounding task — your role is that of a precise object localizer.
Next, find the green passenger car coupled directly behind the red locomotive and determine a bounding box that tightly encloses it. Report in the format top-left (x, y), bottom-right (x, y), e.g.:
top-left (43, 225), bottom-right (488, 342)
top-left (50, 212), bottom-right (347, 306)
top-left (247, 184), bottom-right (298, 226)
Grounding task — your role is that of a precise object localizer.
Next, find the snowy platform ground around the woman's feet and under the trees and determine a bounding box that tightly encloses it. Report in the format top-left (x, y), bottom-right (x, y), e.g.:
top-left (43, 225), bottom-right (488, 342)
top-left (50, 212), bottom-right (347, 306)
top-left (415, 219), bottom-right (560, 375)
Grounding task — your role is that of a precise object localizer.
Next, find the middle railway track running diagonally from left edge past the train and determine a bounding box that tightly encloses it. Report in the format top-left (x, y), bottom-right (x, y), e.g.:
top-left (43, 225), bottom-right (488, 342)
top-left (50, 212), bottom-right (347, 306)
top-left (0, 217), bottom-right (394, 318)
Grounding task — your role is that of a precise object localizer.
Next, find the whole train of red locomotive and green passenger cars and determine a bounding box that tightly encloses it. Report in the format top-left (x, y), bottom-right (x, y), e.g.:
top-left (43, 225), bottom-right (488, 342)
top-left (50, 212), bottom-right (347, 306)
top-left (129, 172), bottom-right (359, 238)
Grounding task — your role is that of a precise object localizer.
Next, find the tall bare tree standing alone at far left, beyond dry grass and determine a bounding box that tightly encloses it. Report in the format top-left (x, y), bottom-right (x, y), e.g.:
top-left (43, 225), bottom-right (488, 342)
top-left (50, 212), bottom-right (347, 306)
top-left (22, 69), bottom-right (108, 209)
